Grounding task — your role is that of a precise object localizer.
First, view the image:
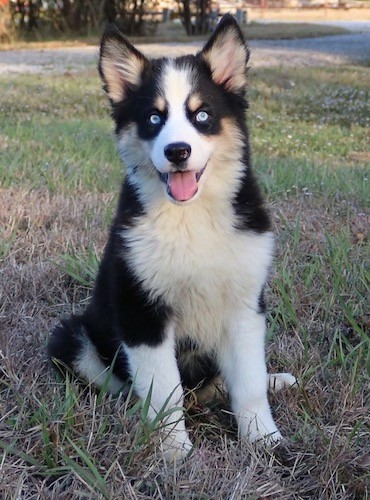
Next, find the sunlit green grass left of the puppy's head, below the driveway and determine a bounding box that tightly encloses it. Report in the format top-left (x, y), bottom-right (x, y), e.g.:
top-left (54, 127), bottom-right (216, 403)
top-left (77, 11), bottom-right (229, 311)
top-left (0, 74), bottom-right (123, 192)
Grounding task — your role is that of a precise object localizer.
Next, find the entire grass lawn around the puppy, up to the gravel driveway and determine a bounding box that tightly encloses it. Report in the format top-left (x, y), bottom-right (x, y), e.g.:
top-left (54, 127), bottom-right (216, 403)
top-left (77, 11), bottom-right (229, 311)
top-left (0, 54), bottom-right (370, 499)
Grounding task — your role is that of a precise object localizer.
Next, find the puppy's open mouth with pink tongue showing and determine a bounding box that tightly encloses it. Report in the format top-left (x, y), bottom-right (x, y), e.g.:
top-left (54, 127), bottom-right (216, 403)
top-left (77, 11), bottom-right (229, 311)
top-left (159, 167), bottom-right (206, 201)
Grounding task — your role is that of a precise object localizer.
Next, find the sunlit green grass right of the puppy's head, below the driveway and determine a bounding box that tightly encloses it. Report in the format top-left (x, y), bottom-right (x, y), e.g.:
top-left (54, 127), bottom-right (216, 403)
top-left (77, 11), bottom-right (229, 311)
top-left (249, 67), bottom-right (370, 206)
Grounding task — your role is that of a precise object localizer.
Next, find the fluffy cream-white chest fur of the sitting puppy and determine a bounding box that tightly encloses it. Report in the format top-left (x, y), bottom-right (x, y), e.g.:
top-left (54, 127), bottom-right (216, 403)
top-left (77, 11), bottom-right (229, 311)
top-left (123, 198), bottom-right (273, 347)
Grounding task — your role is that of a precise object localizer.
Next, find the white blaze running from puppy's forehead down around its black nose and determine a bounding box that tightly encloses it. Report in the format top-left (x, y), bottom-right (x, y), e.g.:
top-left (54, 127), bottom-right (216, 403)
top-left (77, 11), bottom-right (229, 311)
top-left (151, 61), bottom-right (214, 173)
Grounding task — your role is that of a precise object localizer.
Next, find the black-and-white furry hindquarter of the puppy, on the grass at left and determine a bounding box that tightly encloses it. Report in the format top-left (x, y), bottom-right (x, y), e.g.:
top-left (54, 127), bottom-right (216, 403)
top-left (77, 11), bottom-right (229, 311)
top-left (48, 316), bottom-right (124, 393)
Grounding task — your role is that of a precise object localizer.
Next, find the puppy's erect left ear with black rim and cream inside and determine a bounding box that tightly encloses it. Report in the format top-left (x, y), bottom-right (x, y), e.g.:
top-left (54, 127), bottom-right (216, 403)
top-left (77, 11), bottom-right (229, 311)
top-left (99, 25), bottom-right (148, 104)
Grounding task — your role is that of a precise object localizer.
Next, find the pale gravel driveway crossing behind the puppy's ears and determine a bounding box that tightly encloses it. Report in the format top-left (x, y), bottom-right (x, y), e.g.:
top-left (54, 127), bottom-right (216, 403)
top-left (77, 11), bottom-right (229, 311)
top-left (0, 32), bottom-right (370, 74)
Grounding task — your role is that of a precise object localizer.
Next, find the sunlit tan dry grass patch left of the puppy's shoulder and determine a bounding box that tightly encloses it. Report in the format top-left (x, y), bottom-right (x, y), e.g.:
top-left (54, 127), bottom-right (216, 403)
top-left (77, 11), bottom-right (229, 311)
top-left (0, 189), bottom-right (113, 264)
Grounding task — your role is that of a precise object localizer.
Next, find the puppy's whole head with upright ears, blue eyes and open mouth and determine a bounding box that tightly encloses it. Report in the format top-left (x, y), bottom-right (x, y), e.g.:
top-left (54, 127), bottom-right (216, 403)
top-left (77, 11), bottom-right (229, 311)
top-left (99, 15), bottom-right (248, 204)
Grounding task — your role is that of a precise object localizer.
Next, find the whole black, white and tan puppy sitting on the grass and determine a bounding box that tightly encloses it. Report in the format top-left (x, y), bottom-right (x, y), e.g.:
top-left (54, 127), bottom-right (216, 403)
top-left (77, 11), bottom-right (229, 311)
top-left (49, 16), bottom-right (295, 458)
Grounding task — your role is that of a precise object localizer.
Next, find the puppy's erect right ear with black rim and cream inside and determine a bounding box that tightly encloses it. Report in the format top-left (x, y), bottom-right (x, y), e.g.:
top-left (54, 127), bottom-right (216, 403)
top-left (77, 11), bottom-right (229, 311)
top-left (199, 14), bottom-right (249, 92)
